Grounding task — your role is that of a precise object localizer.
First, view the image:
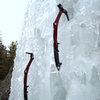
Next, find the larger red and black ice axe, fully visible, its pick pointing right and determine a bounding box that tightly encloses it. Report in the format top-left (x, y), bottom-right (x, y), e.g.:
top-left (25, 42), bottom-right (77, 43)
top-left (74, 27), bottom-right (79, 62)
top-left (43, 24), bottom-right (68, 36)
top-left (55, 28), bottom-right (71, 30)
top-left (53, 4), bottom-right (69, 71)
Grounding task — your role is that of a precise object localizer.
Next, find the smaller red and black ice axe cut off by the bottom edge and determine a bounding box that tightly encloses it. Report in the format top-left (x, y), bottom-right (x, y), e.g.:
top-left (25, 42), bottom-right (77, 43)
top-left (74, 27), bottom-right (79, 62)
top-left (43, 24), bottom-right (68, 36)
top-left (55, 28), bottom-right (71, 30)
top-left (24, 52), bottom-right (34, 100)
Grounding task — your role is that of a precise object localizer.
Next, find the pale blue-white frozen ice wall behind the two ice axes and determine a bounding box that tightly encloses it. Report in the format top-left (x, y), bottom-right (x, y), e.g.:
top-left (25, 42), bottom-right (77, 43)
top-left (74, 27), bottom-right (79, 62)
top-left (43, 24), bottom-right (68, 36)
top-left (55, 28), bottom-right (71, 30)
top-left (9, 0), bottom-right (100, 100)
